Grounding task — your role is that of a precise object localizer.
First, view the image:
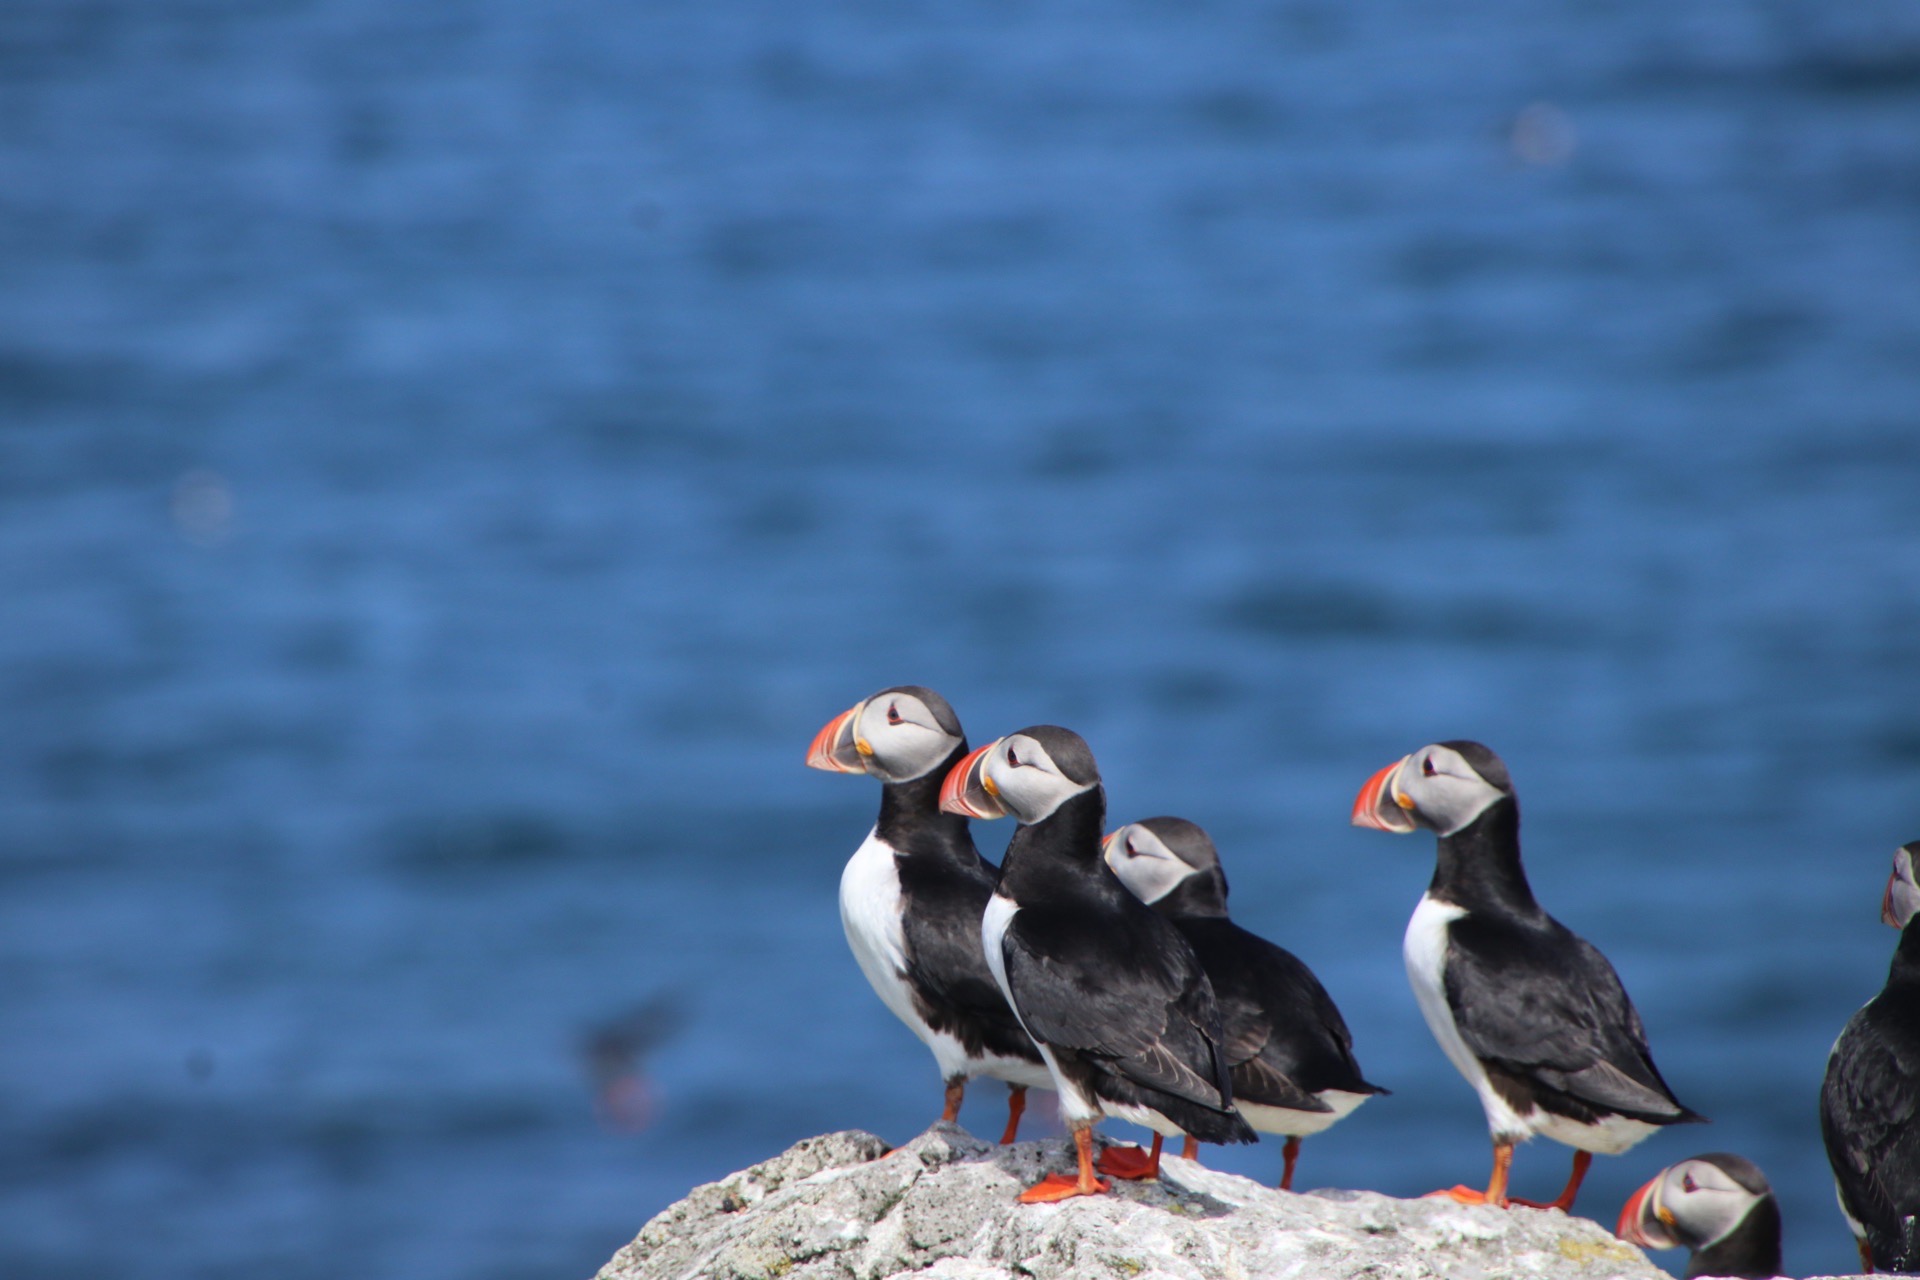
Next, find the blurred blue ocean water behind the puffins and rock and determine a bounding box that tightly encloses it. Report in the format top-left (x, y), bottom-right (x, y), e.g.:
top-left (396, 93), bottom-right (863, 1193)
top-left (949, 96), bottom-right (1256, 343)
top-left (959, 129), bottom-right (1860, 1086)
top-left (0, 0), bottom-right (1920, 1280)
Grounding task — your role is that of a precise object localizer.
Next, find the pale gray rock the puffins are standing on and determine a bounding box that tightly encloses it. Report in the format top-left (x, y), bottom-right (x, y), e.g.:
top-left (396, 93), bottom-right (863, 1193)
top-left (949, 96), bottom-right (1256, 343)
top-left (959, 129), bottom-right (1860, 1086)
top-left (599, 1125), bottom-right (1668, 1280)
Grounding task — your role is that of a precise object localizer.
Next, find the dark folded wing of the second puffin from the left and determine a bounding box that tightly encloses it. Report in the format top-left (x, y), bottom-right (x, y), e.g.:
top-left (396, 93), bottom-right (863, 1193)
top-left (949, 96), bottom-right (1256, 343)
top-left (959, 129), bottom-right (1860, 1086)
top-left (1004, 900), bottom-right (1233, 1109)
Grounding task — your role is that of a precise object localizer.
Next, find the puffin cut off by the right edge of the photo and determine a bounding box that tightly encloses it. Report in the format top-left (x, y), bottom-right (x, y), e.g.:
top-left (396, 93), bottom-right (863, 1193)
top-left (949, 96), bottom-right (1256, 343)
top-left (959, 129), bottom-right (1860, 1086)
top-left (1820, 841), bottom-right (1920, 1270)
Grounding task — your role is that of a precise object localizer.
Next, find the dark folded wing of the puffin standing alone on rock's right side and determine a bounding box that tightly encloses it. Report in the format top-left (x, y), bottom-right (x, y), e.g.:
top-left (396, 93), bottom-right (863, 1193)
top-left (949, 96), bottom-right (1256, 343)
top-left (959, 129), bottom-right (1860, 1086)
top-left (1446, 915), bottom-right (1699, 1125)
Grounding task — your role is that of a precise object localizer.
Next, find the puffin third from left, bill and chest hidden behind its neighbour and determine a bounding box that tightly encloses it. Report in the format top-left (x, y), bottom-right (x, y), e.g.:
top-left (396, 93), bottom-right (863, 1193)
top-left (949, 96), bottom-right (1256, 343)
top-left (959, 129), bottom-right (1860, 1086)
top-left (1104, 818), bottom-right (1388, 1192)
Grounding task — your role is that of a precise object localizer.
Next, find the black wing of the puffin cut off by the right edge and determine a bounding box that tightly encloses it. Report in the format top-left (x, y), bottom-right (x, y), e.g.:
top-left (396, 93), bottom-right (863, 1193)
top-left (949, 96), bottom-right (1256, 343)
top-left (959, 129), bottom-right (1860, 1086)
top-left (1820, 996), bottom-right (1920, 1270)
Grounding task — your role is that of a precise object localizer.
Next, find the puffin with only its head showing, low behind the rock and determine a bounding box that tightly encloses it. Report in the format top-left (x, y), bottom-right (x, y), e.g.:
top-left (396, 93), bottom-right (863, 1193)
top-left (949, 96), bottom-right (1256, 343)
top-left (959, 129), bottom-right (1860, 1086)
top-left (1613, 1151), bottom-right (1780, 1280)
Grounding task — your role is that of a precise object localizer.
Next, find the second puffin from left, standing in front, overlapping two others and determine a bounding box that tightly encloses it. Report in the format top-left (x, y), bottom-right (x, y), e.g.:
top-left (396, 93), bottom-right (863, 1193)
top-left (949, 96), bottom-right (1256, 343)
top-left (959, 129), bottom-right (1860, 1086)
top-left (941, 725), bottom-right (1256, 1203)
